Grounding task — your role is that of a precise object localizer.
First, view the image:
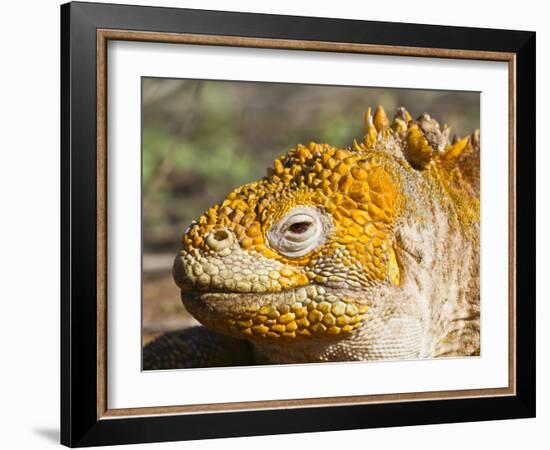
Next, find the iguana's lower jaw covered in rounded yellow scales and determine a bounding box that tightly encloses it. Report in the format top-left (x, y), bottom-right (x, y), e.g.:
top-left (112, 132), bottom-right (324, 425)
top-left (181, 284), bottom-right (372, 343)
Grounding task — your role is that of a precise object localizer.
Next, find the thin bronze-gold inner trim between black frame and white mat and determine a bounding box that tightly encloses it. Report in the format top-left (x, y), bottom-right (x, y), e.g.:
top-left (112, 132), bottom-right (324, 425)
top-left (96, 29), bottom-right (516, 420)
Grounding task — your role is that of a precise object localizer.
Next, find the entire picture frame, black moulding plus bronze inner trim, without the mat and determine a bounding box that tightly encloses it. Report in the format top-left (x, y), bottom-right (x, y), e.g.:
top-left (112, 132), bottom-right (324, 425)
top-left (61, 2), bottom-right (535, 446)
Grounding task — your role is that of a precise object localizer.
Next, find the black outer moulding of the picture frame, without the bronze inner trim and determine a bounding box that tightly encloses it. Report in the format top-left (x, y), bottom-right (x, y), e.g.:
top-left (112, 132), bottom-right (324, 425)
top-left (61, 2), bottom-right (535, 447)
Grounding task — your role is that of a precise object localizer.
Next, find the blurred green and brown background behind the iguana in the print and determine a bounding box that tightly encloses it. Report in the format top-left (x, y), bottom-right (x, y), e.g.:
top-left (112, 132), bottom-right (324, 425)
top-left (142, 78), bottom-right (480, 342)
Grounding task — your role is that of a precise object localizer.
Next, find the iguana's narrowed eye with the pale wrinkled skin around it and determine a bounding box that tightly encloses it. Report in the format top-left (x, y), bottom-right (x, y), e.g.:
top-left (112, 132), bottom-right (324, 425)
top-left (267, 206), bottom-right (331, 257)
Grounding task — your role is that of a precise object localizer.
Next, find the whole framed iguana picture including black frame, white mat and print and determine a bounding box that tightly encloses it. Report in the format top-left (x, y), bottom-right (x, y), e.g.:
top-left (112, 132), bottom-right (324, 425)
top-left (61, 3), bottom-right (535, 447)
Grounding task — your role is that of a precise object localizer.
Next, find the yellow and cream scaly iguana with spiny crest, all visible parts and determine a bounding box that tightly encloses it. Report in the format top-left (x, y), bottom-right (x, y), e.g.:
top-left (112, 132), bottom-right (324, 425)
top-left (144, 106), bottom-right (480, 369)
